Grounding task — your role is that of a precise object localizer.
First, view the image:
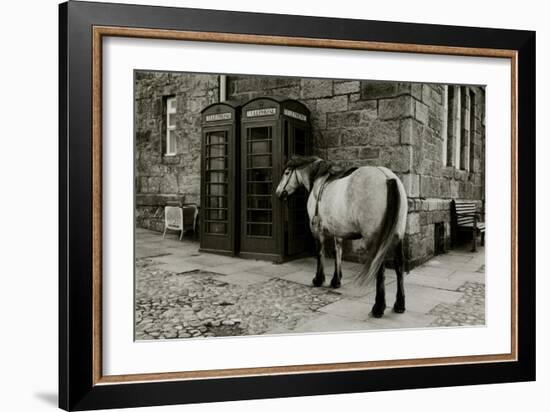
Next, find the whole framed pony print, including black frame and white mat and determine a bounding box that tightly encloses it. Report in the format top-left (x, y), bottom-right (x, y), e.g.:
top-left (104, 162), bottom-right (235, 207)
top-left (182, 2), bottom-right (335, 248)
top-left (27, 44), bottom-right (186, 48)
top-left (59, 1), bottom-right (535, 410)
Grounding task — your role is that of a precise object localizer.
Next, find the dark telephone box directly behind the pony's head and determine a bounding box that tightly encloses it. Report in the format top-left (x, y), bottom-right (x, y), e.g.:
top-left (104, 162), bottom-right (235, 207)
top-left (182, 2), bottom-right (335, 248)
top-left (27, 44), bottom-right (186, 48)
top-left (239, 97), bottom-right (311, 262)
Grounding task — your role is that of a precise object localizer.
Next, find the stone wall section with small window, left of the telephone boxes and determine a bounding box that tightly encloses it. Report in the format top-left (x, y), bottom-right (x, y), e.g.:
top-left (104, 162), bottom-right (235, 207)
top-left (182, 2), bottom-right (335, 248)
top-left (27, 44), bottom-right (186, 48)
top-left (135, 72), bottom-right (219, 231)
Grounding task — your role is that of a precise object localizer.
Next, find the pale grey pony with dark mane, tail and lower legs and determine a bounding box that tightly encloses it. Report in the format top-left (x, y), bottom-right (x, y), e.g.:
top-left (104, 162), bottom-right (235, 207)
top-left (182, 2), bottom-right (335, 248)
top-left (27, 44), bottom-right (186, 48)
top-left (275, 156), bottom-right (407, 318)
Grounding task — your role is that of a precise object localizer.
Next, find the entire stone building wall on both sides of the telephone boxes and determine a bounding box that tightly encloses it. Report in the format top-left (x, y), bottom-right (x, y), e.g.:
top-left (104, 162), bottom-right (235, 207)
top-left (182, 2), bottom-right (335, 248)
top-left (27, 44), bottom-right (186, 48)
top-left (136, 73), bottom-right (485, 265)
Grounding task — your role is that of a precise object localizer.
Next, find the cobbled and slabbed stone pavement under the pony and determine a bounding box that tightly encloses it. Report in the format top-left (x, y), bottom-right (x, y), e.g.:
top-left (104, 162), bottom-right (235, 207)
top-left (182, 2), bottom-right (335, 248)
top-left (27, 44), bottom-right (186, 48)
top-left (135, 229), bottom-right (485, 340)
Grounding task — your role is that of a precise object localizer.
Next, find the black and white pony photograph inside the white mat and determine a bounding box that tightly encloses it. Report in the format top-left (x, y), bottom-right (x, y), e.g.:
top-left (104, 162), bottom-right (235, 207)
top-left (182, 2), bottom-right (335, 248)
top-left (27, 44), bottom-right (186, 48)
top-left (133, 69), bottom-right (486, 341)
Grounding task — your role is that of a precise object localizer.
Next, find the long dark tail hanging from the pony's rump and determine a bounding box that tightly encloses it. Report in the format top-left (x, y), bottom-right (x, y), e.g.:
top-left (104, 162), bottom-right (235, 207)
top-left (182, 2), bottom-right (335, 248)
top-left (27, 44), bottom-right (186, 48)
top-left (356, 177), bottom-right (401, 286)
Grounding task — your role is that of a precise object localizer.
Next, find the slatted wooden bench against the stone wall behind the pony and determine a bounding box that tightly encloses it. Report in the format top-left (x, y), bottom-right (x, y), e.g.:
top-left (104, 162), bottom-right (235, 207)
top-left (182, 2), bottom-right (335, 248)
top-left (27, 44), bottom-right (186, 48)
top-left (451, 199), bottom-right (485, 252)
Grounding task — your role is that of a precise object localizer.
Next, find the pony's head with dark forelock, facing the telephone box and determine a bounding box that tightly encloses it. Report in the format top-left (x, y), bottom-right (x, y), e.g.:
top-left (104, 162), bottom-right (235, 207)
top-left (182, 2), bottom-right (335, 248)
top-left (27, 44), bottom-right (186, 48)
top-left (275, 156), bottom-right (328, 199)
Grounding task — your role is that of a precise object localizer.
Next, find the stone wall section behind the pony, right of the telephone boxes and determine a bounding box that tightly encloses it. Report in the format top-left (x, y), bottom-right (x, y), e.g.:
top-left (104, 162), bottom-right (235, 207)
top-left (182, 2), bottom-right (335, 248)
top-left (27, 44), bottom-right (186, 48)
top-left (228, 76), bottom-right (485, 265)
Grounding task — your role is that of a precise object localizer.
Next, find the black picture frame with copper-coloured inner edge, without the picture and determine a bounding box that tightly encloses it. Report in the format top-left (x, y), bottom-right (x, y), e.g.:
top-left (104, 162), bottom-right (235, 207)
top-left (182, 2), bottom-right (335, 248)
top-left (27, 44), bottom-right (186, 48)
top-left (59, 1), bottom-right (535, 410)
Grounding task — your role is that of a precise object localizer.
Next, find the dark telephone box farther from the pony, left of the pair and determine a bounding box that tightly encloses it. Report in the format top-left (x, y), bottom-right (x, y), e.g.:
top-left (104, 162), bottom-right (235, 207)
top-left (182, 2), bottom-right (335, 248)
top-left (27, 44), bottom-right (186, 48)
top-left (200, 101), bottom-right (240, 255)
